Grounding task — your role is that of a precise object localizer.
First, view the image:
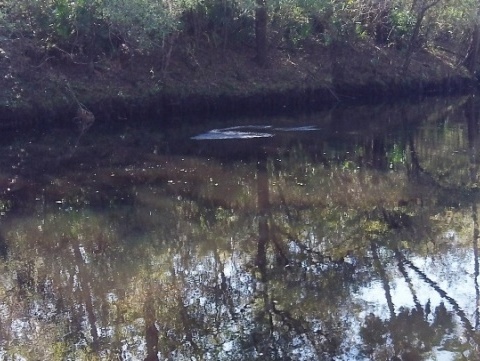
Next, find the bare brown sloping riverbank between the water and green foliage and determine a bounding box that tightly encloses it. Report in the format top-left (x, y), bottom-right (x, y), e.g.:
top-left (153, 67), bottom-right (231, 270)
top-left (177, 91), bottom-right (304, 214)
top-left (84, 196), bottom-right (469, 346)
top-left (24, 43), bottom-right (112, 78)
top-left (0, 40), bottom-right (476, 129)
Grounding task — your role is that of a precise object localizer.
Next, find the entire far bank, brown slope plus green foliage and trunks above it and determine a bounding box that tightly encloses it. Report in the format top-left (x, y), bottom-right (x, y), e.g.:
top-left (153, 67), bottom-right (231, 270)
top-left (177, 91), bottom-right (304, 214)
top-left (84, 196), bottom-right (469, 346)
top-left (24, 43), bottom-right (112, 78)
top-left (0, 0), bottom-right (480, 128)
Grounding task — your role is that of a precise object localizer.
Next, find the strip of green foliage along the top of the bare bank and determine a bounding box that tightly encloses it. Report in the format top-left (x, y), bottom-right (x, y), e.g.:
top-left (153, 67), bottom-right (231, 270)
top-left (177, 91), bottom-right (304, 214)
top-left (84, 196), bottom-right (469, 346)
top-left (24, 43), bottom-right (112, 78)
top-left (0, 0), bottom-right (478, 65)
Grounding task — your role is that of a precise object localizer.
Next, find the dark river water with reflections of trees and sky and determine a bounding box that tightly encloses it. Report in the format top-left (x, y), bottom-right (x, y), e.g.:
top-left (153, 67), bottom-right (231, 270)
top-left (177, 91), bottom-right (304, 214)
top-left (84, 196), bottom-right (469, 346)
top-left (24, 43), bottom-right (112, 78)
top-left (0, 97), bottom-right (480, 361)
